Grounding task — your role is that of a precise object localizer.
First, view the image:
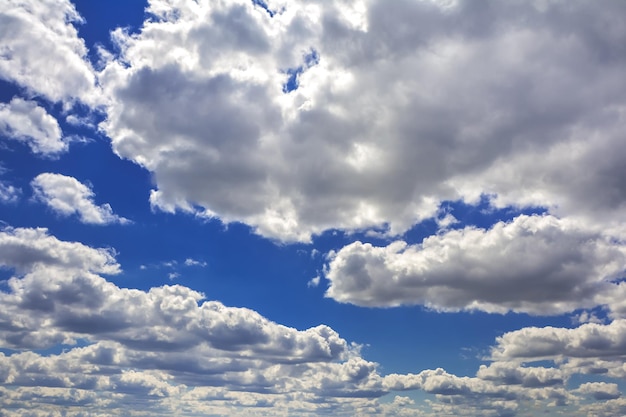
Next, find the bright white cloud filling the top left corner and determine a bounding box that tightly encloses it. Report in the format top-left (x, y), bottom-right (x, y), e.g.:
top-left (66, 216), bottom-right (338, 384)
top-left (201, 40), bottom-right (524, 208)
top-left (0, 0), bottom-right (97, 105)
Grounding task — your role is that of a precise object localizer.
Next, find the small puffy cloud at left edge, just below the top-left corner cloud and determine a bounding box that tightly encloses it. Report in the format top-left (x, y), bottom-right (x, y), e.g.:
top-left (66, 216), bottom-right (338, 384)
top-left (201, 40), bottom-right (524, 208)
top-left (0, 97), bottom-right (68, 155)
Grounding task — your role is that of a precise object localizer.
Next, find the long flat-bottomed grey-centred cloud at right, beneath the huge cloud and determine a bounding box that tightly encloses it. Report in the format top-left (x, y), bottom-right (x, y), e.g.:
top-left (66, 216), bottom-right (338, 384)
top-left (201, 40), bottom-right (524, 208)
top-left (326, 215), bottom-right (626, 315)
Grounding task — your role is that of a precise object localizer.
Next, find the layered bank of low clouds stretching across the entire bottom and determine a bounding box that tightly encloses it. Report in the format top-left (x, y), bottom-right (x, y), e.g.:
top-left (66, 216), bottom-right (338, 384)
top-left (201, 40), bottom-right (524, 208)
top-left (0, 228), bottom-right (626, 417)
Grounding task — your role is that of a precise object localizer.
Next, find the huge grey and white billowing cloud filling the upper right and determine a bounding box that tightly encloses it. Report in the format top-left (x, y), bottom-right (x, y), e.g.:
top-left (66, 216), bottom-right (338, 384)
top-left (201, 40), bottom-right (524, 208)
top-left (100, 0), bottom-right (626, 241)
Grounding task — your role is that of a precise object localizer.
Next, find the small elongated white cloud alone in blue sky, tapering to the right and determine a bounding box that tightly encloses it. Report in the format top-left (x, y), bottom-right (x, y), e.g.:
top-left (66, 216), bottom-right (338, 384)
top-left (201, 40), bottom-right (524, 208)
top-left (31, 173), bottom-right (128, 224)
